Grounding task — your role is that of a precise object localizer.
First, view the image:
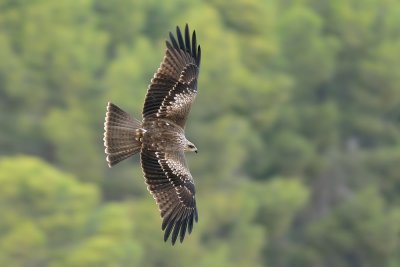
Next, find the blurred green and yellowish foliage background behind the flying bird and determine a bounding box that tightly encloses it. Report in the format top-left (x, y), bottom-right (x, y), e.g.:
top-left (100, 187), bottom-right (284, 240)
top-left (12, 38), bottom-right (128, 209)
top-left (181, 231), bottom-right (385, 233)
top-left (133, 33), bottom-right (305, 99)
top-left (0, 0), bottom-right (400, 267)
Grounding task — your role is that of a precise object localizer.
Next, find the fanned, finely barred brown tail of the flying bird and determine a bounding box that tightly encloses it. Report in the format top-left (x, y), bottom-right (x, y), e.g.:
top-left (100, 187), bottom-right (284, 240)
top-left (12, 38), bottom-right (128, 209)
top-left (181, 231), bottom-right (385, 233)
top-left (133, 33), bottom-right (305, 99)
top-left (103, 102), bottom-right (144, 167)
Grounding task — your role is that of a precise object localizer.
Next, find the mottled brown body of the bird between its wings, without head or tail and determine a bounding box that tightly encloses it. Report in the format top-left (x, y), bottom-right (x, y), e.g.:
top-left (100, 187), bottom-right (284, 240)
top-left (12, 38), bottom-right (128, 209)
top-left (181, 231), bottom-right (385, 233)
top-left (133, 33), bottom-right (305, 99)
top-left (142, 118), bottom-right (186, 151)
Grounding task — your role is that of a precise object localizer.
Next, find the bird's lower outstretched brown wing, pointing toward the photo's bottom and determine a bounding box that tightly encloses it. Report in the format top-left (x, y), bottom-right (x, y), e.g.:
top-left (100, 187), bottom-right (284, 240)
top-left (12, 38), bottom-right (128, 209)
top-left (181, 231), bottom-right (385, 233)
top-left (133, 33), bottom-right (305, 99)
top-left (141, 150), bottom-right (198, 244)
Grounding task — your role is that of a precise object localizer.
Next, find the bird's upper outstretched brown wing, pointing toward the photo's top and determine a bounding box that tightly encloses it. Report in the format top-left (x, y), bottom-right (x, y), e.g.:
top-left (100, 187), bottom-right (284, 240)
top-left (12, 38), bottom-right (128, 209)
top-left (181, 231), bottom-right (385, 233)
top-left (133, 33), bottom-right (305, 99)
top-left (143, 24), bottom-right (201, 128)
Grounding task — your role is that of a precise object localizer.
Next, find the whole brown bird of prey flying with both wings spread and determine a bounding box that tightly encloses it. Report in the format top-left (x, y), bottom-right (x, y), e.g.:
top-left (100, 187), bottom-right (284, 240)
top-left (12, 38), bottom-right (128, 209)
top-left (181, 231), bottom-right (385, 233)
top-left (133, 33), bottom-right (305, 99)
top-left (104, 24), bottom-right (201, 244)
